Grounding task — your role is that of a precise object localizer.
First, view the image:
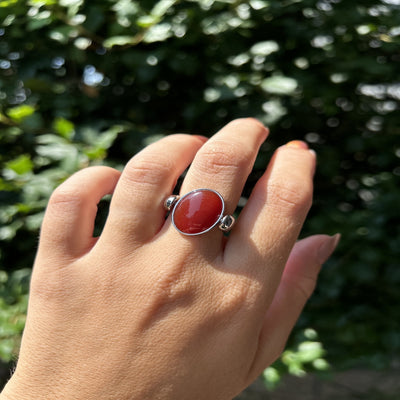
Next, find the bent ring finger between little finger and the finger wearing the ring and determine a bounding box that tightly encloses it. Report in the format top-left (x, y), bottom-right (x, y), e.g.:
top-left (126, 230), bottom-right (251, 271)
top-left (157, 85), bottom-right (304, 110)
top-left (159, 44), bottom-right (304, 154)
top-left (100, 134), bottom-right (207, 245)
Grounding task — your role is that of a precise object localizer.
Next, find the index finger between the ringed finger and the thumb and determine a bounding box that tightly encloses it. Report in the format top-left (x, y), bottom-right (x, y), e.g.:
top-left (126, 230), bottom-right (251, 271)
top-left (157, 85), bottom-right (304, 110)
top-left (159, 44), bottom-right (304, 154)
top-left (225, 142), bottom-right (315, 282)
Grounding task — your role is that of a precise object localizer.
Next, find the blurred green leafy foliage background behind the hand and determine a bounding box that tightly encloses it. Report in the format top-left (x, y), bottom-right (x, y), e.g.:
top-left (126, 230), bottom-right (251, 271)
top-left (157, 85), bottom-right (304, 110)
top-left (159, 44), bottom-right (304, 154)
top-left (0, 0), bottom-right (400, 400)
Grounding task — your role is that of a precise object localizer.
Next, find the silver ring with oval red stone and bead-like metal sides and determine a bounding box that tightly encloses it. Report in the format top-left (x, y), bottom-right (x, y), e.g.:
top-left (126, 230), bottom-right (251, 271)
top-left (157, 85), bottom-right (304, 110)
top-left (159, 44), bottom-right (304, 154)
top-left (164, 189), bottom-right (235, 236)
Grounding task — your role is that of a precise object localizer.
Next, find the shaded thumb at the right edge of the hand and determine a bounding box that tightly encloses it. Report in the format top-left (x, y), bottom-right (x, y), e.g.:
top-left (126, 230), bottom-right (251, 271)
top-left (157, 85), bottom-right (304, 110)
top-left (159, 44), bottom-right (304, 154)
top-left (248, 235), bottom-right (340, 378)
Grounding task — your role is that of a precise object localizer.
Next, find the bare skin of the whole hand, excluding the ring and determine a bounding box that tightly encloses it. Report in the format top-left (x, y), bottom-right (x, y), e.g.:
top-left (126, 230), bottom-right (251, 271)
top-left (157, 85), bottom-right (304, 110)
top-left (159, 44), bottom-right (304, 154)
top-left (0, 119), bottom-right (338, 400)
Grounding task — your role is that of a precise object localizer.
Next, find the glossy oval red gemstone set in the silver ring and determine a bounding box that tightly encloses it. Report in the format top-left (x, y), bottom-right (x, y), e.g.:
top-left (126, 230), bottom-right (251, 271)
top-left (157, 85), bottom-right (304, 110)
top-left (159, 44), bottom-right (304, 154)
top-left (172, 189), bottom-right (224, 235)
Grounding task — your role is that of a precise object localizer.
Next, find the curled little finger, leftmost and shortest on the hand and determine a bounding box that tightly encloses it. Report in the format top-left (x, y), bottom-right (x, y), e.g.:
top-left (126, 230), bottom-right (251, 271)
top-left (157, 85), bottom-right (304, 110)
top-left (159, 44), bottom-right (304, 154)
top-left (39, 167), bottom-right (120, 258)
